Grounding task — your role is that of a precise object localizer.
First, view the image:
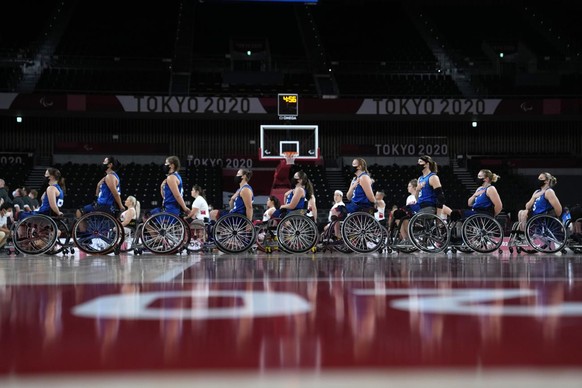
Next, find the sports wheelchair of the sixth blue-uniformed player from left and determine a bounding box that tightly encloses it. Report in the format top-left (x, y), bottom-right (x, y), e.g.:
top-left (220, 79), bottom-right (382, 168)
top-left (320, 208), bottom-right (386, 253)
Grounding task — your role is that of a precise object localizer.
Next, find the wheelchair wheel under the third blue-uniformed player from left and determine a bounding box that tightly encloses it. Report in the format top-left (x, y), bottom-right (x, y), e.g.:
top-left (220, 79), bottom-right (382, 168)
top-left (141, 212), bottom-right (190, 255)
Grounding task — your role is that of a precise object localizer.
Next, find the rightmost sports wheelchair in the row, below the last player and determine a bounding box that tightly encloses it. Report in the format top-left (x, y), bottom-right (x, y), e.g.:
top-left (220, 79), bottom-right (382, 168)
top-left (508, 214), bottom-right (568, 253)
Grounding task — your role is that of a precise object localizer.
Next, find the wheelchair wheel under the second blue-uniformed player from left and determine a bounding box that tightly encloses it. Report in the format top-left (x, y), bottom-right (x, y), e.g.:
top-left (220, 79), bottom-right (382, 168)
top-left (72, 212), bottom-right (124, 255)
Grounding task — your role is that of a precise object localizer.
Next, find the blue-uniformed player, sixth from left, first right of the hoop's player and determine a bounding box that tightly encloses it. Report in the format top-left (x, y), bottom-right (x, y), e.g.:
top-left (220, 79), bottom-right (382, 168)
top-left (346, 158), bottom-right (376, 213)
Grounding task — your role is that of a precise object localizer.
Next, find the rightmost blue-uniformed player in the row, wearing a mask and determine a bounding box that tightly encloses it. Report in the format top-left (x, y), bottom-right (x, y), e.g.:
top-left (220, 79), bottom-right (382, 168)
top-left (517, 172), bottom-right (562, 231)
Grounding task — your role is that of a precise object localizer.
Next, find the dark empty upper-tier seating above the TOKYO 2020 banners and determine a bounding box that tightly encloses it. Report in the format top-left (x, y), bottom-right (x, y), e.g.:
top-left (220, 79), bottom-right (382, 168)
top-left (0, 0), bottom-right (582, 97)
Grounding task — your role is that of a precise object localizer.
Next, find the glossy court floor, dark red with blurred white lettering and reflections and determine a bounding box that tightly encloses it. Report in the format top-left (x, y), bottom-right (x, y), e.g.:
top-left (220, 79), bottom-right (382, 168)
top-left (0, 250), bottom-right (582, 387)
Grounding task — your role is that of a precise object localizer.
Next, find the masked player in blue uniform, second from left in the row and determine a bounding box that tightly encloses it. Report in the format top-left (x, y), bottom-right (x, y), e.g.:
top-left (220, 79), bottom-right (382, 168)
top-left (76, 156), bottom-right (125, 217)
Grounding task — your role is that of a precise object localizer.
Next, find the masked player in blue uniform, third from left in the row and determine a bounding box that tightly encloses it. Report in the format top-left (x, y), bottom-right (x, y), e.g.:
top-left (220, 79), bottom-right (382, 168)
top-left (150, 156), bottom-right (190, 216)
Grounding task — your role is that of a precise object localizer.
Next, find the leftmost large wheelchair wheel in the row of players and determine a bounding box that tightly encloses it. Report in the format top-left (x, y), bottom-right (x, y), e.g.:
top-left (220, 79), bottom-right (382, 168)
top-left (13, 214), bottom-right (58, 255)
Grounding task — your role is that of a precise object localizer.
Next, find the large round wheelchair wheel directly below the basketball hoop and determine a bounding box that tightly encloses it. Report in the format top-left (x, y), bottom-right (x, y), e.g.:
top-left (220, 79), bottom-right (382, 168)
top-left (277, 214), bottom-right (318, 253)
